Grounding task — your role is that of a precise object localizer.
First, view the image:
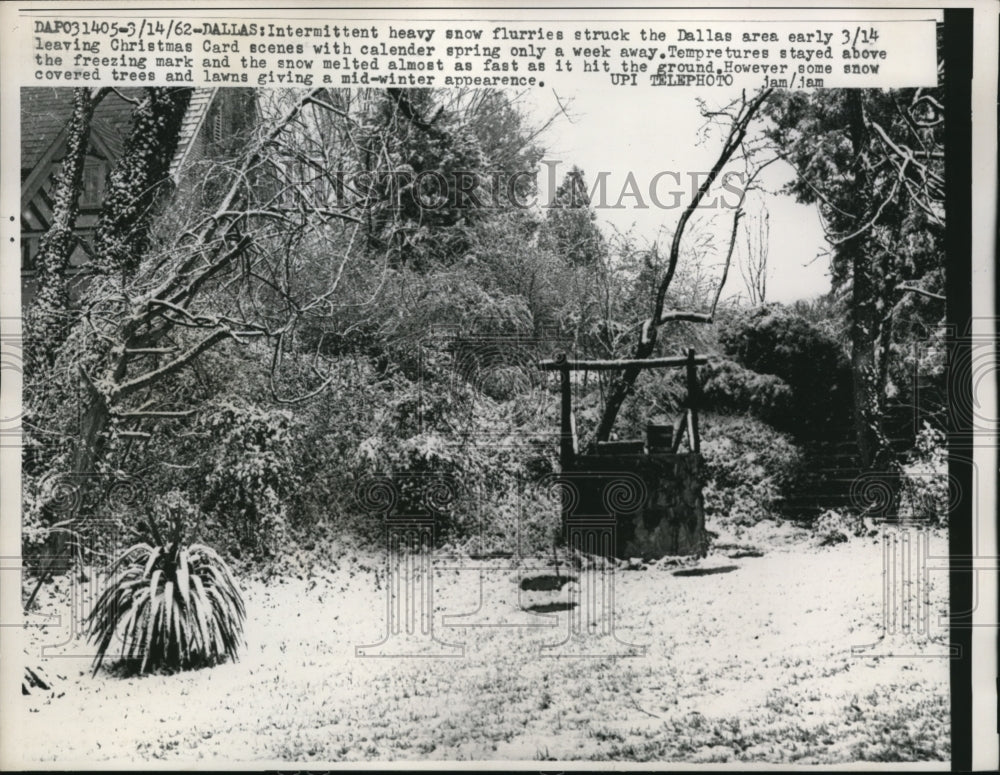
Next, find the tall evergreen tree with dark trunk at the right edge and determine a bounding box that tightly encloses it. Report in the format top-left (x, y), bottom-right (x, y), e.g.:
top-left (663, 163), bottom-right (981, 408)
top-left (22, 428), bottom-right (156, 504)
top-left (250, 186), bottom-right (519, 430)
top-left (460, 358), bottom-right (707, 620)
top-left (766, 83), bottom-right (944, 470)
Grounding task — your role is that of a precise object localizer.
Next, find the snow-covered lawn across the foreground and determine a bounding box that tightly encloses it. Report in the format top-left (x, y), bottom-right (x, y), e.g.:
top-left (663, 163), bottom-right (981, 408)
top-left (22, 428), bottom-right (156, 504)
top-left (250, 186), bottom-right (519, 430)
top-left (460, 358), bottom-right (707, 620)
top-left (17, 524), bottom-right (950, 767)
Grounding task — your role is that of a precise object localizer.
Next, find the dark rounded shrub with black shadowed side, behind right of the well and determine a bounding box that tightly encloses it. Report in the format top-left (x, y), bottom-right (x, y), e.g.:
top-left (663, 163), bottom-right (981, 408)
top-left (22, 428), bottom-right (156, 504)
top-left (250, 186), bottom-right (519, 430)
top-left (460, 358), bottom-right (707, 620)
top-left (719, 305), bottom-right (852, 439)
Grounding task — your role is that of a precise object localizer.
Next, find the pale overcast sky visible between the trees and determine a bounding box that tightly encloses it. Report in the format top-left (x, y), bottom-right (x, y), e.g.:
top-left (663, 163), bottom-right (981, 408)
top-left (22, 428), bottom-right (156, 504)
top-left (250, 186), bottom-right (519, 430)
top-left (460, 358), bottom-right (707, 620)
top-left (527, 87), bottom-right (830, 302)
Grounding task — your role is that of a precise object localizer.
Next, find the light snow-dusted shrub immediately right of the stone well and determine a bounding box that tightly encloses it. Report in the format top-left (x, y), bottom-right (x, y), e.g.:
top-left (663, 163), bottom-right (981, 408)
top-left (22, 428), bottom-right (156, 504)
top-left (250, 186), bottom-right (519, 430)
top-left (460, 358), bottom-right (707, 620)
top-left (701, 414), bottom-right (802, 525)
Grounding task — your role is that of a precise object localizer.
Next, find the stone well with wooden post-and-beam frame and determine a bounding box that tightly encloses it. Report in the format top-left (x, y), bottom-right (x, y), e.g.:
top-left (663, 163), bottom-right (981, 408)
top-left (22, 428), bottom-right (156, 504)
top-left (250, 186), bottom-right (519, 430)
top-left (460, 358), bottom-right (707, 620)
top-left (539, 349), bottom-right (708, 558)
